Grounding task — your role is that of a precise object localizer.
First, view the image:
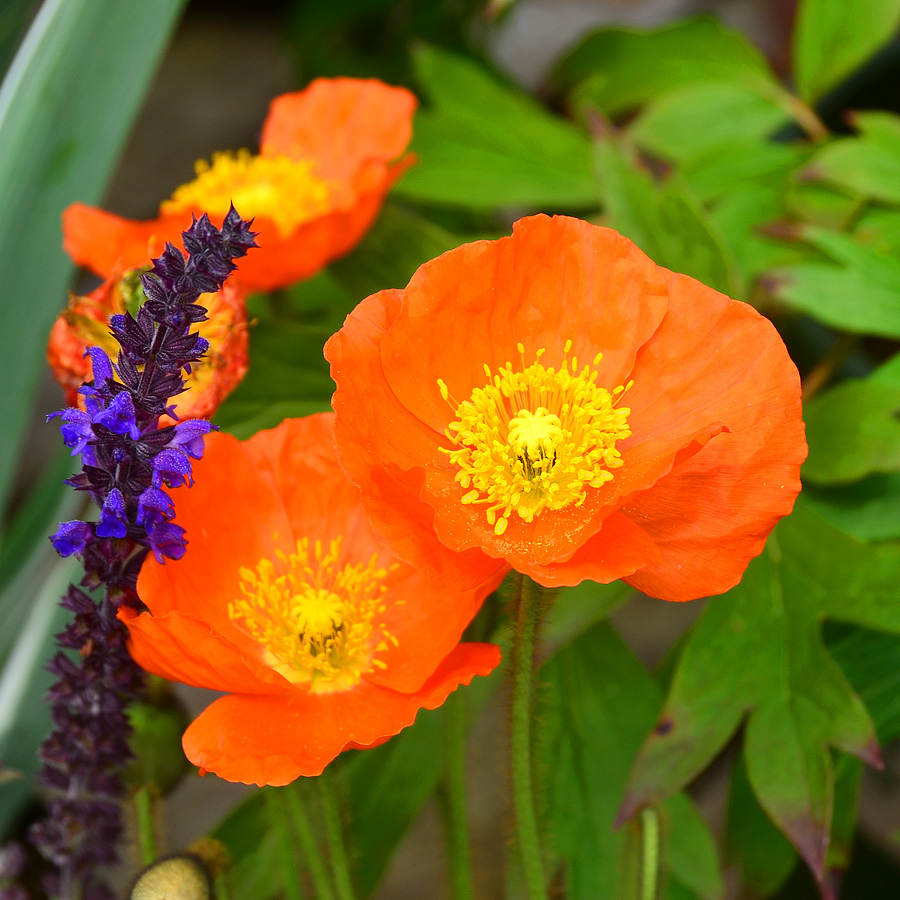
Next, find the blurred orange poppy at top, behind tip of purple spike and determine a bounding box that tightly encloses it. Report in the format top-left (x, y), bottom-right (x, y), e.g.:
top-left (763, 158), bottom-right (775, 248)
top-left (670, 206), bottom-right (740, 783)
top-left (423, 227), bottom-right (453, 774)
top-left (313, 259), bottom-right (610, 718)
top-left (63, 78), bottom-right (416, 291)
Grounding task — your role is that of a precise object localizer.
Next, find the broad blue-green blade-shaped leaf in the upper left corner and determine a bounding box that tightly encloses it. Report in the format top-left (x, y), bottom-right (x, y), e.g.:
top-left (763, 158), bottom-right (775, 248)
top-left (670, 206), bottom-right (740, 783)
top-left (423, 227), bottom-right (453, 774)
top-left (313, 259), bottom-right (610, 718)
top-left (0, 0), bottom-right (184, 536)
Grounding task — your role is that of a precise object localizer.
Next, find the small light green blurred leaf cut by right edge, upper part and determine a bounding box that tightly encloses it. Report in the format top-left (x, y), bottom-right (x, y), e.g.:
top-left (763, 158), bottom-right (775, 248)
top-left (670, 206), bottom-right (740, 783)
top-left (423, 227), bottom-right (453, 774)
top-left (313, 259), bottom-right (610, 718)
top-left (800, 137), bottom-right (900, 204)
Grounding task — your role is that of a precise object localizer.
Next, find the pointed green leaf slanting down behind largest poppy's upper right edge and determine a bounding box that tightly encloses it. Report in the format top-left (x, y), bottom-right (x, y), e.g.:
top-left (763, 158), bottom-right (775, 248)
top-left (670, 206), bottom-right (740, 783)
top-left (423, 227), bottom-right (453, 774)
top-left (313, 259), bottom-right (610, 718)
top-left (595, 138), bottom-right (740, 296)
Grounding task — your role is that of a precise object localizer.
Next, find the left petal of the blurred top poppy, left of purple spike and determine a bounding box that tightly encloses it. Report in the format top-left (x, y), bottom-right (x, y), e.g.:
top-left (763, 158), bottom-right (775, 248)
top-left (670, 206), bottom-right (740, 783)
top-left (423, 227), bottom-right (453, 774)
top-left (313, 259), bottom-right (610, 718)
top-left (63, 203), bottom-right (171, 278)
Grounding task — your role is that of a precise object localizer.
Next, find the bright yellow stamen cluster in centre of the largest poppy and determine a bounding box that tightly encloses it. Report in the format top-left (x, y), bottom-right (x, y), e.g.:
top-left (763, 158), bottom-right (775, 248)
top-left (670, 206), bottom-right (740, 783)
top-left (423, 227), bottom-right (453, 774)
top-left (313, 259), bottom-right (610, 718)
top-left (438, 341), bottom-right (631, 535)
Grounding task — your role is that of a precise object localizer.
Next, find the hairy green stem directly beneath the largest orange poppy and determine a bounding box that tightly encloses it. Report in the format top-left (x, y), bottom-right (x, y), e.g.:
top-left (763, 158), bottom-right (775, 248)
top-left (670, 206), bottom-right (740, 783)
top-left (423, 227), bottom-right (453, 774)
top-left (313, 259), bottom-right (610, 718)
top-left (511, 576), bottom-right (547, 900)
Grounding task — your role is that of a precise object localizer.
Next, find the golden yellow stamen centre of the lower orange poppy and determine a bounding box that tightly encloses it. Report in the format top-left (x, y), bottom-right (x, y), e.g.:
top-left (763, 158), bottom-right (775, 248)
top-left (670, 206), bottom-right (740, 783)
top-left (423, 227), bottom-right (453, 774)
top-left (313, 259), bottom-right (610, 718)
top-left (228, 538), bottom-right (396, 693)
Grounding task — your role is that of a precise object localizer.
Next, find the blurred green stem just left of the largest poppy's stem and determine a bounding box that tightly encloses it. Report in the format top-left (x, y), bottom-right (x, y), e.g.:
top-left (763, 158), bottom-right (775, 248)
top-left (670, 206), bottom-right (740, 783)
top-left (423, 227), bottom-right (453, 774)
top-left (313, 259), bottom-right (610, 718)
top-left (441, 691), bottom-right (474, 900)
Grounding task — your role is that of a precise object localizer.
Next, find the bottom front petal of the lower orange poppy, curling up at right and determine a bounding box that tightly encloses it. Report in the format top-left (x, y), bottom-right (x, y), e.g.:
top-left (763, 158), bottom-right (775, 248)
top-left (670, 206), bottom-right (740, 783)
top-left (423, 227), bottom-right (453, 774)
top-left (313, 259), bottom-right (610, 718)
top-left (182, 644), bottom-right (500, 785)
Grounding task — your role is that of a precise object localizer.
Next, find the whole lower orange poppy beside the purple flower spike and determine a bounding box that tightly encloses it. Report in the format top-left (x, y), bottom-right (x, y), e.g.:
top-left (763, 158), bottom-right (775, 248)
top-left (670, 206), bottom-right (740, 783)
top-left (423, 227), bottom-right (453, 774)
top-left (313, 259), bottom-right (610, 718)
top-left (119, 413), bottom-right (500, 785)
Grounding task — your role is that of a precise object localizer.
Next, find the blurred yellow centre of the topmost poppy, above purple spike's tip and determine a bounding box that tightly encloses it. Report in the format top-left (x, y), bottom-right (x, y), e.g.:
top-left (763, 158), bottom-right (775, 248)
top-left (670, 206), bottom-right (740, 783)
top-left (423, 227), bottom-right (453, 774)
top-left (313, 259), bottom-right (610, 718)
top-left (162, 150), bottom-right (330, 236)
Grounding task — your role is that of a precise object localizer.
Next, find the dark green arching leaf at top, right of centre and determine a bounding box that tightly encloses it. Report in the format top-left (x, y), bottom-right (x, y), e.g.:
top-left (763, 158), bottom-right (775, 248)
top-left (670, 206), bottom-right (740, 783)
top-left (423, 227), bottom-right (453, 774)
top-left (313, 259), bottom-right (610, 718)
top-left (551, 16), bottom-right (774, 116)
